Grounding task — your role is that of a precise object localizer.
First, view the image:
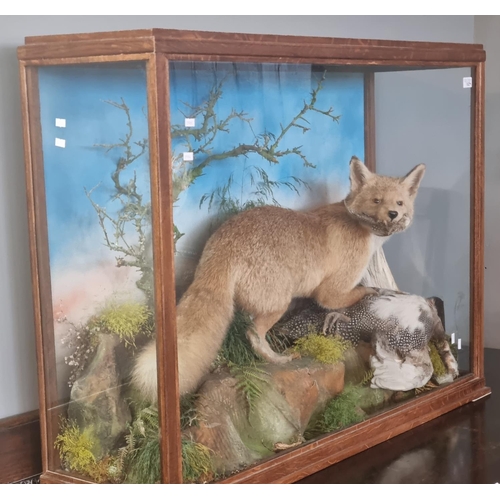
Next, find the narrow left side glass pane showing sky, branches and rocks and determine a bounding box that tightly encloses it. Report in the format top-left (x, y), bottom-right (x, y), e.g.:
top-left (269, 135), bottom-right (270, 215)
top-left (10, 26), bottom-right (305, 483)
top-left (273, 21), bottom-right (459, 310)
top-left (39, 62), bottom-right (159, 482)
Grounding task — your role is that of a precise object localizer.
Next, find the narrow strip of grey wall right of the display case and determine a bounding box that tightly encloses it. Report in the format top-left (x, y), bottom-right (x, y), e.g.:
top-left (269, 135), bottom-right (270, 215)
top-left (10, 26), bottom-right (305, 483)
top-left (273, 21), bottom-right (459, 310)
top-left (474, 16), bottom-right (500, 349)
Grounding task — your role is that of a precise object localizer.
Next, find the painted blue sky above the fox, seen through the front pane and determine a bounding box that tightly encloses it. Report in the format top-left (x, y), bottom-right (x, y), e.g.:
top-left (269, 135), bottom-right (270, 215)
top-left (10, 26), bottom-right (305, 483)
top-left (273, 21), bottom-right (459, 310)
top-left (170, 62), bottom-right (364, 251)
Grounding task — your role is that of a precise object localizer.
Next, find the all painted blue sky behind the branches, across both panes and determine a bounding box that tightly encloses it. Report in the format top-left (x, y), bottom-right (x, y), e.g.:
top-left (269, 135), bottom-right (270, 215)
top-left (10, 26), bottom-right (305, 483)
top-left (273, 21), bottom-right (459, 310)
top-left (39, 62), bottom-right (364, 265)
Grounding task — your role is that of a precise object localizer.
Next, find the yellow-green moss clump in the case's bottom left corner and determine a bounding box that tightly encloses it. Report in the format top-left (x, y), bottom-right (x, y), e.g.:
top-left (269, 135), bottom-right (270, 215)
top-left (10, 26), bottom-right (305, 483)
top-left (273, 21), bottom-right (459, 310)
top-left (54, 418), bottom-right (97, 476)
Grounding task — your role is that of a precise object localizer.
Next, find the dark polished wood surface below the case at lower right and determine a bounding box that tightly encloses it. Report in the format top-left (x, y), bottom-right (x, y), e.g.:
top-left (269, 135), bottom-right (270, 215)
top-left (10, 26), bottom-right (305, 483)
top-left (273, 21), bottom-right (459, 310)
top-left (298, 349), bottom-right (500, 484)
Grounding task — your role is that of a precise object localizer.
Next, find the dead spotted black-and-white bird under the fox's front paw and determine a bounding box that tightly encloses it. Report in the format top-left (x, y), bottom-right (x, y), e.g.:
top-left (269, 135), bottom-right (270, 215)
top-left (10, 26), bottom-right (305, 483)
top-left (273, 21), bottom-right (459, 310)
top-left (273, 289), bottom-right (458, 384)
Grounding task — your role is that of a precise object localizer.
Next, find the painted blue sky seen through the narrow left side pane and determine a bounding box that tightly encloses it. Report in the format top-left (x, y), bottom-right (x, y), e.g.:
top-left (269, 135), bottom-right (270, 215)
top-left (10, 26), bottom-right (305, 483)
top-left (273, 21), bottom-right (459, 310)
top-left (39, 62), bottom-right (150, 264)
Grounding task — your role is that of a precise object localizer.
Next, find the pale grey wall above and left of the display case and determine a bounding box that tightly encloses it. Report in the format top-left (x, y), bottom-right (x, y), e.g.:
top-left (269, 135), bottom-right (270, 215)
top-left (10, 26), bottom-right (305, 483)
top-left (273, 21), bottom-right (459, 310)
top-left (0, 16), bottom-right (476, 418)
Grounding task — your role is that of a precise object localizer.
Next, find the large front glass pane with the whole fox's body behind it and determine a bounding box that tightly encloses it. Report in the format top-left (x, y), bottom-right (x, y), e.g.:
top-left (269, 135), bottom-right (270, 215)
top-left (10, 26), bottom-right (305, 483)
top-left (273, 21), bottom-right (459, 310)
top-left (161, 62), bottom-right (470, 482)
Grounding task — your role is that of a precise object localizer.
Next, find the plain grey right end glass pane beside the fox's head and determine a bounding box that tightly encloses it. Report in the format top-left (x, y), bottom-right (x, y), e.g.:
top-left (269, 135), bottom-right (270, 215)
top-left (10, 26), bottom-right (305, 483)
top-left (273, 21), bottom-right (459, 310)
top-left (375, 68), bottom-right (471, 373)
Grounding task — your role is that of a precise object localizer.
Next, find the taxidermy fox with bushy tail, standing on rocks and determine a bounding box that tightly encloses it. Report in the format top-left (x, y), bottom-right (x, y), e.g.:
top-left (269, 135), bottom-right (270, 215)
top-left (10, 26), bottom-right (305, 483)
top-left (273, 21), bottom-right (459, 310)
top-left (132, 157), bottom-right (425, 401)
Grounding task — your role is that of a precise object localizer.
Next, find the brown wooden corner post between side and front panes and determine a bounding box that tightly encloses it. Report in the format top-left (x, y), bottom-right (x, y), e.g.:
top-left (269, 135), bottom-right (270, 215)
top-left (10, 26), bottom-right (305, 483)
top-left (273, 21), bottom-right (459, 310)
top-left (148, 55), bottom-right (182, 483)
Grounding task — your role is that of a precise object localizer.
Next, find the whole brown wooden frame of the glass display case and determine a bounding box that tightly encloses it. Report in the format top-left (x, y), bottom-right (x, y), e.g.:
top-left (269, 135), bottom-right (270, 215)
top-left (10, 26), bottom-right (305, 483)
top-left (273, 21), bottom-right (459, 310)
top-left (18, 29), bottom-right (490, 483)
